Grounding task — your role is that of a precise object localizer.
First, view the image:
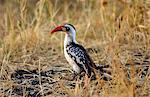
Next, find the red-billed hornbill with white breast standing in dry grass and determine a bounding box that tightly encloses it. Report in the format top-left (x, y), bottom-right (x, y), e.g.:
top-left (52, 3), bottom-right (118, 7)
top-left (51, 24), bottom-right (108, 77)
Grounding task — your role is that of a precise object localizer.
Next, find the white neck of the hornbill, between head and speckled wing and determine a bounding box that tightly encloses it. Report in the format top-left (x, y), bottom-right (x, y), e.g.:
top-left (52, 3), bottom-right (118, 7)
top-left (64, 34), bottom-right (77, 47)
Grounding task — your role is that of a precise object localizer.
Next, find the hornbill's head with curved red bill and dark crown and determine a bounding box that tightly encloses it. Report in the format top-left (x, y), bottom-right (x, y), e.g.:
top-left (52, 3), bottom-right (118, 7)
top-left (50, 23), bottom-right (76, 37)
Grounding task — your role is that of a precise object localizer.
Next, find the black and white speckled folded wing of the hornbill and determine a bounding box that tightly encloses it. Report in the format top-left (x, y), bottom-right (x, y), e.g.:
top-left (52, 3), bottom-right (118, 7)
top-left (66, 43), bottom-right (95, 76)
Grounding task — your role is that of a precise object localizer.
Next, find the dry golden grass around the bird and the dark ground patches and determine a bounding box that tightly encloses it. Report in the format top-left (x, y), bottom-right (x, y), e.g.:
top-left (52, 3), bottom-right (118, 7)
top-left (0, 0), bottom-right (150, 97)
